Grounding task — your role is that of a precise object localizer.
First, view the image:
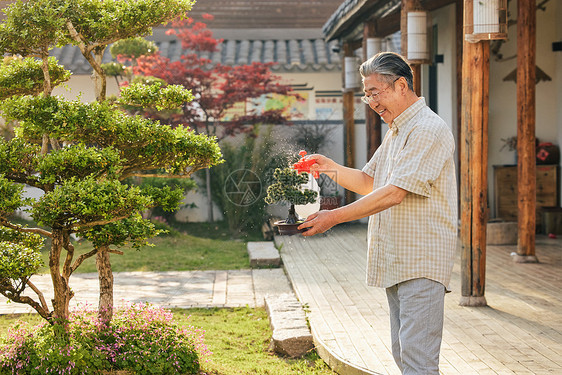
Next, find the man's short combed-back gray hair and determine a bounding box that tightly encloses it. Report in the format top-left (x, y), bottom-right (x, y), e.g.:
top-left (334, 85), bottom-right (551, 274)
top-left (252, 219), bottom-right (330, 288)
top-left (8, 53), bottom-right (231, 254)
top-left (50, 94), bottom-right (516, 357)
top-left (359, 52), bottom-right (414, 91)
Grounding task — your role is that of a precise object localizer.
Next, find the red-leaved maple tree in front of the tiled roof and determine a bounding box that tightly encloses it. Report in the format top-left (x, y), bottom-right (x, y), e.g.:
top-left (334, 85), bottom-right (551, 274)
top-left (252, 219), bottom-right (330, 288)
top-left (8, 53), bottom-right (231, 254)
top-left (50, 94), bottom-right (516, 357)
top-left (127, 15), bottom-right (299, 221)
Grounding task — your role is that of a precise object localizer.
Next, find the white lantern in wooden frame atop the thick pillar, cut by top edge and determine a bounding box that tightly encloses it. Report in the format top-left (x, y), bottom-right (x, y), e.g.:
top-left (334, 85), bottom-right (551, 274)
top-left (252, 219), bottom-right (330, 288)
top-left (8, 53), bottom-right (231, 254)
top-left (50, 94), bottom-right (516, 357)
top-left (464, 0), bottom-right (507, 43)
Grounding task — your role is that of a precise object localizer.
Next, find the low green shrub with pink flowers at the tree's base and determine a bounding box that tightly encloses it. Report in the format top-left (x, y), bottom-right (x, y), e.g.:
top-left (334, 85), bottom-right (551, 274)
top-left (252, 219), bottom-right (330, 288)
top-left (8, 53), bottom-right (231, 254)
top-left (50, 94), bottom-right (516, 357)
top-left (0, 304), bottom-right (209, 375)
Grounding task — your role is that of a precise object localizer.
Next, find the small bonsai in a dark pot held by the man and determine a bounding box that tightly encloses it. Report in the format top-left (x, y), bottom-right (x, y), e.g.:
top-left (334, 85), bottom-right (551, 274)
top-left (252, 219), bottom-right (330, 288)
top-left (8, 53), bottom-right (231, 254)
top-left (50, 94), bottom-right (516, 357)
top-left (265, 167), bottom-right (318, 235)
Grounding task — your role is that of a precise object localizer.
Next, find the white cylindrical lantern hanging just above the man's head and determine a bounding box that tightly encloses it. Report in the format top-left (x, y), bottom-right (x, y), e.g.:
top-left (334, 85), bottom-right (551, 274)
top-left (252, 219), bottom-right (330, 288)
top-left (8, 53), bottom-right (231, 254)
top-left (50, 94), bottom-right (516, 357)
top-left (406, 10), bottom-right (429, 64)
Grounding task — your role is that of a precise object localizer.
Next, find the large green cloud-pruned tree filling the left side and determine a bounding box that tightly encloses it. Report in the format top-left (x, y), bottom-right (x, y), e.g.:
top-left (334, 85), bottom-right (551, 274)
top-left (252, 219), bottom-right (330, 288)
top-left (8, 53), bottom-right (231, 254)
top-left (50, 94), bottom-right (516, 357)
top-left (0, 0), bottom-right (221, 332)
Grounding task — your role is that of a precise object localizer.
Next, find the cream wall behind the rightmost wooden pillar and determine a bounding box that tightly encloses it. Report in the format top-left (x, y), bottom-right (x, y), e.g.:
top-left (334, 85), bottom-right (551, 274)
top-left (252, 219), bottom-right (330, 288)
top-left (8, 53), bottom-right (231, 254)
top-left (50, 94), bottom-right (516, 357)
top-left (488, 1), bottom-right (562, 217)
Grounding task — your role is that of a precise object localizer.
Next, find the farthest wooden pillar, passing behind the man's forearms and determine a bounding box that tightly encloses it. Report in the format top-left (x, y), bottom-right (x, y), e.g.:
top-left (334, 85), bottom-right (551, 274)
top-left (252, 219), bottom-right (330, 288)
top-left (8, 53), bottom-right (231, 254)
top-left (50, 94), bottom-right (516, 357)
top-left (342, 43), bottom-right (355, 204)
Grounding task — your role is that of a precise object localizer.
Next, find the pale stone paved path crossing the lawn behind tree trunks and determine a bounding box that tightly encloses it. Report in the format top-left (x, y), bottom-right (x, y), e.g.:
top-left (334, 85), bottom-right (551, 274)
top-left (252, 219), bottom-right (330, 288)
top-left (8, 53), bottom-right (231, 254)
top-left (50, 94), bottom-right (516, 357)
top-left (0, 268), bottom-right (292, 314)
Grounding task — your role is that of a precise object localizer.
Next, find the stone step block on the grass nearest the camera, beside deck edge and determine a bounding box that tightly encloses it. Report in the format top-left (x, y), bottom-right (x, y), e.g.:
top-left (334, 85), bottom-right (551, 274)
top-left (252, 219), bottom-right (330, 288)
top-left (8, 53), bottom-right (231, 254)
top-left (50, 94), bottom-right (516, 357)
top-left (265, 293), bottom-right (314, 358)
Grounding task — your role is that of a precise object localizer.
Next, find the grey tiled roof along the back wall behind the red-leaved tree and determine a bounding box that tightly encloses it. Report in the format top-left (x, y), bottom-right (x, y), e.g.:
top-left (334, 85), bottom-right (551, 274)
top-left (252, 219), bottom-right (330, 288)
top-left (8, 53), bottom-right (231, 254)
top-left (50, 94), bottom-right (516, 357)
top-left (51, 31), bottom-right (341, 74)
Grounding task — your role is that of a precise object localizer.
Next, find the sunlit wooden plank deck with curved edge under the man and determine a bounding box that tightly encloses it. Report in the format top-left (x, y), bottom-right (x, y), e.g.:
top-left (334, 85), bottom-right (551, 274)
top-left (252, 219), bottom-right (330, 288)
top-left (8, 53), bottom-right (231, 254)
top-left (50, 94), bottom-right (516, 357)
top-left (276, 225), bottom-right (562, 375)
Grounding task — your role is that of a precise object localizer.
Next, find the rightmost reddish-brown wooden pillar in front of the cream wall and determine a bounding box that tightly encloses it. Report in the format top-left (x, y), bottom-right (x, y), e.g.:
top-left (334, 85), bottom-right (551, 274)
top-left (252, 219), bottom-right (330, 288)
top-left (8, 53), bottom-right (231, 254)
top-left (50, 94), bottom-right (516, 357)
top-left (513, 0), bottom-right (538, 263)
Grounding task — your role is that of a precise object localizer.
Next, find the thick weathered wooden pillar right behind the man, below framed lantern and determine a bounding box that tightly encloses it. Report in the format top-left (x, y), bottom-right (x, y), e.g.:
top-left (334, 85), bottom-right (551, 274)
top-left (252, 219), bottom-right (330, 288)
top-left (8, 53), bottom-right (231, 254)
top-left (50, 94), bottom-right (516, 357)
top-left (459, 41), bottom-right (490, 306)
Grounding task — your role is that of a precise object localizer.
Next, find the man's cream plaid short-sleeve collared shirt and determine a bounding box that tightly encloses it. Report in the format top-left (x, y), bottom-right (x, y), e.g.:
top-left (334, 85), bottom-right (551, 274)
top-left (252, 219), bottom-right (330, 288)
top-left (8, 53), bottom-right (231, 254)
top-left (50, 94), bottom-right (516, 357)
top-left (363, 98), bottom-right (458, 288)
